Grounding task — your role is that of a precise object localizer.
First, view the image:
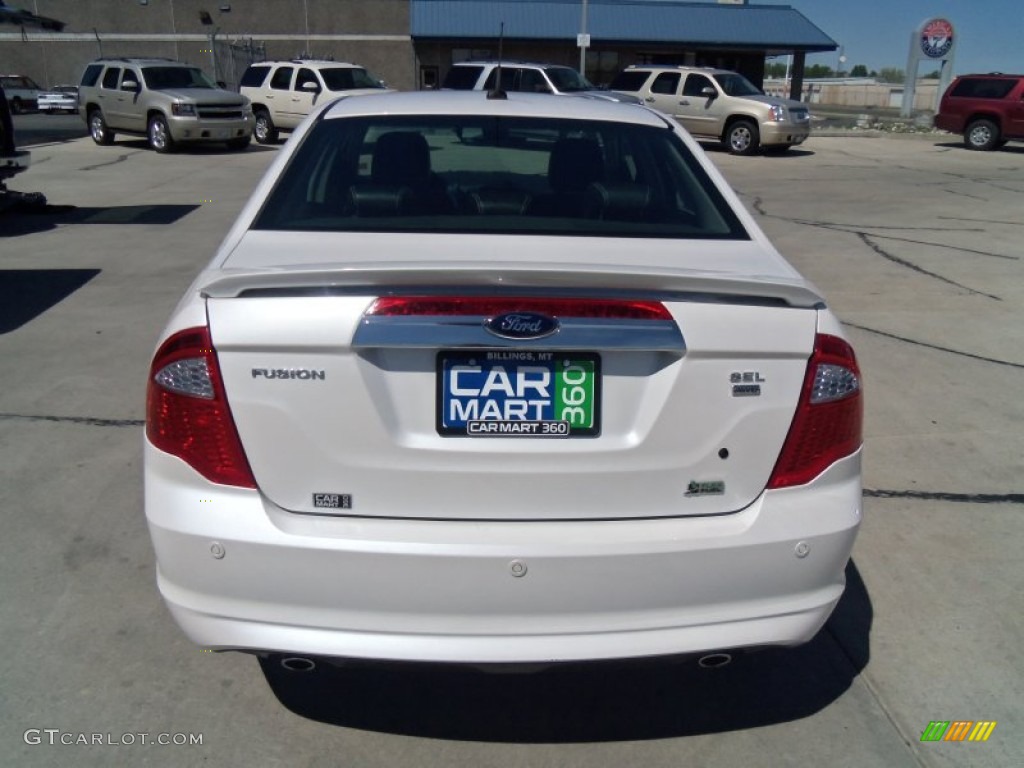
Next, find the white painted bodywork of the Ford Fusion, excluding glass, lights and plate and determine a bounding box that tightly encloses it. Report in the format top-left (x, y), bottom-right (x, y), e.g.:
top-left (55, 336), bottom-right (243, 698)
top-left (145, 92), bottom-right (861, 664)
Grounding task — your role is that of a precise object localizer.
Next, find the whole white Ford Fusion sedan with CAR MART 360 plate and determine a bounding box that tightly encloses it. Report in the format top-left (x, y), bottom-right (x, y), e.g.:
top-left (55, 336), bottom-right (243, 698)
top-left (145, 92), bottom-right (862, 669)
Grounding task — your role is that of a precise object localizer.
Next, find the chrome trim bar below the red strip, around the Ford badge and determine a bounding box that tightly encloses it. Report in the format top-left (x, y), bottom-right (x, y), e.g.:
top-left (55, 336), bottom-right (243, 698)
top-left (352, 315), bottom-right (686, 355)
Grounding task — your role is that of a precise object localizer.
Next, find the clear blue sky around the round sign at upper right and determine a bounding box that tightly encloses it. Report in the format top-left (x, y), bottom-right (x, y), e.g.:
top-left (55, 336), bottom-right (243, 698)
top-left (770, 0), bottom-right (1024, 75)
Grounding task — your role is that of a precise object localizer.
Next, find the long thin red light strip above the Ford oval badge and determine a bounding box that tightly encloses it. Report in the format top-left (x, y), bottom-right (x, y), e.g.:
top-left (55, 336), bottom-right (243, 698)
top-left (367, 296), bottom-right (672, 321)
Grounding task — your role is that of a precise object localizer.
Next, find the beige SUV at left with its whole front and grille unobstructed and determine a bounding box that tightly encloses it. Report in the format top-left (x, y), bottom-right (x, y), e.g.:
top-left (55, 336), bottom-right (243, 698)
top-left (78, 58), bottom-right (253, 153)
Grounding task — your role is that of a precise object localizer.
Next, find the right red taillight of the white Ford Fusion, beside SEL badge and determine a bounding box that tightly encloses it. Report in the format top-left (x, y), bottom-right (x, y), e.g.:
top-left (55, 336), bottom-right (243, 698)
top-left (768, 334), bottom-right (864, 488)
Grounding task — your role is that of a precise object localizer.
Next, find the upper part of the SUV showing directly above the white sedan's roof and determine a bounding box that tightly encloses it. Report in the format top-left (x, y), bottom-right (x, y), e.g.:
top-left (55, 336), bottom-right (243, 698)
top-left (441, 61), bottom-right (640, 103)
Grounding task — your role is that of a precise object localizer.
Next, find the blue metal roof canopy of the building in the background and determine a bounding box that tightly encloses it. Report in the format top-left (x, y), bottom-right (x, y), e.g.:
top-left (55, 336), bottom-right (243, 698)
top-left (410, 0), bottom-right (839, 53)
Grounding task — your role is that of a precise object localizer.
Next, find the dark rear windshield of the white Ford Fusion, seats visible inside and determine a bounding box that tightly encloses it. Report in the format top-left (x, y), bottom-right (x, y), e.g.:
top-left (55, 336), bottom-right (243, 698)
top-left (247, 116), bottom-right (748, 240)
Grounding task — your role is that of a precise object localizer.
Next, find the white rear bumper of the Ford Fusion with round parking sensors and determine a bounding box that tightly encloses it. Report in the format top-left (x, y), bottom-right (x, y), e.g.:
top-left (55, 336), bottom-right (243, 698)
top-left (145, 443), bottom-right (861, 664)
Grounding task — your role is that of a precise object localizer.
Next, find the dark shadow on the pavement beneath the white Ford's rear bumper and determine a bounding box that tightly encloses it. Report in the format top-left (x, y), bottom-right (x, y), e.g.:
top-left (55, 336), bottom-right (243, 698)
top-left (260, 561), bottom-right (872, 743)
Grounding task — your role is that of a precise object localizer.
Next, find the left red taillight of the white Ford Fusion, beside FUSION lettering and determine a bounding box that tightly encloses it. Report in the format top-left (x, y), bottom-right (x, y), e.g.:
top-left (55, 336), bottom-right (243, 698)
top-left (145, 328), bottom-right (256, 488)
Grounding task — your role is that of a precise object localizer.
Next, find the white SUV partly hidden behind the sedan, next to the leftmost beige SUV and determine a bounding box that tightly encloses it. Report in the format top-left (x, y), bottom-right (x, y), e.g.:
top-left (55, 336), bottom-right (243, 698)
top-left (239, 58), bottom-right (390, 144)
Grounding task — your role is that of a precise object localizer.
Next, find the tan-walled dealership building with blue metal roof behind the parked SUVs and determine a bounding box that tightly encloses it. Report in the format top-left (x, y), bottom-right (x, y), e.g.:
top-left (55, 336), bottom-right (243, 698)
top-left (0, 0), bottom-right (839, 94)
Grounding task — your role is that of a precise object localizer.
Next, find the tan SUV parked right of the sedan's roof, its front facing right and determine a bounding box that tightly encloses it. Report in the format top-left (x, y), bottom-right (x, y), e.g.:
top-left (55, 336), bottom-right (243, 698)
top-left (610, 66), bottom-right (811, 155)
